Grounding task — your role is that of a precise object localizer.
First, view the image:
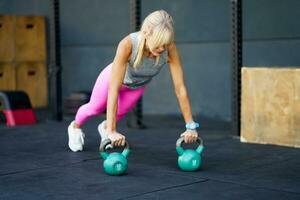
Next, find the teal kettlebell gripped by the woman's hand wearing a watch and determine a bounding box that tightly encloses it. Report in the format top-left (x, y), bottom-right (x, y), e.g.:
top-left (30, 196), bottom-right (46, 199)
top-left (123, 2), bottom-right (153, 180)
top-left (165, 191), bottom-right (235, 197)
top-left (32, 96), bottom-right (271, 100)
top-left (176, 137), bottom-right (204, 171)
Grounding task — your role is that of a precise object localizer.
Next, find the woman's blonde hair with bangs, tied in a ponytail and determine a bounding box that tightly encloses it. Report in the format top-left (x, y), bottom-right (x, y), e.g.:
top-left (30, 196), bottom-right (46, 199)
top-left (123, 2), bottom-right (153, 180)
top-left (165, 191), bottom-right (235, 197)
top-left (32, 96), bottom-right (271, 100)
top-left (133, 10), bottom-right (174, 68)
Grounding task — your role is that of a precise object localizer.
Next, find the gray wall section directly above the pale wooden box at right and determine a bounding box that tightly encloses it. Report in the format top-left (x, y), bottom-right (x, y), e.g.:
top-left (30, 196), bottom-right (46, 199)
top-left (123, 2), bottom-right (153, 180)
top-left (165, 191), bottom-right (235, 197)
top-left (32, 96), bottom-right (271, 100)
top-left (243, 0), bottom-right (300, 67)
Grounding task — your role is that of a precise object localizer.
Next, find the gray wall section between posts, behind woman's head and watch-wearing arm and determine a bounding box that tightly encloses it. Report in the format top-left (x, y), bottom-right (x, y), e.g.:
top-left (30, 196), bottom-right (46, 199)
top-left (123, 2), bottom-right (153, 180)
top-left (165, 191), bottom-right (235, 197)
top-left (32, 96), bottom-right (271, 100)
top-left (142, 0), bottom-right (230, 121)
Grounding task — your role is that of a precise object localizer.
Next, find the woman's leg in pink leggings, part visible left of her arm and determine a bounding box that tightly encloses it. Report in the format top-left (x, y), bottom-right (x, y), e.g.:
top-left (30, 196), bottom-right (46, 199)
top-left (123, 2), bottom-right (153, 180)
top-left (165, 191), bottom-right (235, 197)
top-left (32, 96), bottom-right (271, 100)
top-left (75, 64), bottom-right (111, 126)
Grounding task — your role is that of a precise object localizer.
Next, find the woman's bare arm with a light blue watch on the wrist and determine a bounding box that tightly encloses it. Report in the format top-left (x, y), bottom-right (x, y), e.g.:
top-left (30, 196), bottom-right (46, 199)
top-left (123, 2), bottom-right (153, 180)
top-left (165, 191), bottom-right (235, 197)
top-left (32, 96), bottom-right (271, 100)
top-left (168, 43), bottom-right (196, 142)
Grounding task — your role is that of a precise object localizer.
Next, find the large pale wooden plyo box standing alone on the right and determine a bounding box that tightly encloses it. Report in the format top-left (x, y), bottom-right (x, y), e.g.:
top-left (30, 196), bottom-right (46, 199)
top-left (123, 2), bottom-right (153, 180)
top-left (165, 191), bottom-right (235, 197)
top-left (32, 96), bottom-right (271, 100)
top-left (240, 67), bottom-right (300, 147)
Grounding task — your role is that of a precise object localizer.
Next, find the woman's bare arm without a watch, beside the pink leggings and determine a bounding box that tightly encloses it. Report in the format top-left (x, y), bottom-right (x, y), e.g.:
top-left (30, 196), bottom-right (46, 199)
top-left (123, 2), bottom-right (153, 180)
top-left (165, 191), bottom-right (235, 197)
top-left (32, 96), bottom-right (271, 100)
top-left (106, 36), bottom-right (131, 146)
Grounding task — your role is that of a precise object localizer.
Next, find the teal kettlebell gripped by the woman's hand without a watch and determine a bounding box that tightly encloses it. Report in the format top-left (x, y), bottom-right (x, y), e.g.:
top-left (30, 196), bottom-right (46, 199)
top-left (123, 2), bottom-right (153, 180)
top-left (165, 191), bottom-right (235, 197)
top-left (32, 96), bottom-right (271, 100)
top-left (99, 139), bottom-right (130, 176)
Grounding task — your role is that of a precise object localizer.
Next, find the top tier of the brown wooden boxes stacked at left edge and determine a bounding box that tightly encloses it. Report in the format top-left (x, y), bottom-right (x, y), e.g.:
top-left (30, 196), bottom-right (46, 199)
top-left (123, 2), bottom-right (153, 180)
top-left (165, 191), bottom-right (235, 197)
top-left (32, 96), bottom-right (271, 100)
top-left (0, 15), bottom-right (46, 62)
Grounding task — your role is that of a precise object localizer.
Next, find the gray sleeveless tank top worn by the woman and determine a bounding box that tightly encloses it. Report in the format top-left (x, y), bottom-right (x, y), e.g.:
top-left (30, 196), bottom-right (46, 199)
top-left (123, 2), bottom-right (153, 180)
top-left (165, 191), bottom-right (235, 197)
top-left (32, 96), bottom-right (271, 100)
top-left (123, 32), bottom-right (168, 89)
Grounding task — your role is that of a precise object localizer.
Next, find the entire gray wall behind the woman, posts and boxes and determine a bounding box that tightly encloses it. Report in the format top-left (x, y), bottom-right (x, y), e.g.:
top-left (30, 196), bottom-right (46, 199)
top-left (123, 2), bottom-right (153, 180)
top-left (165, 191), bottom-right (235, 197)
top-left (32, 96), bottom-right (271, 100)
top-left (0, 0), bottom-right (300, 121)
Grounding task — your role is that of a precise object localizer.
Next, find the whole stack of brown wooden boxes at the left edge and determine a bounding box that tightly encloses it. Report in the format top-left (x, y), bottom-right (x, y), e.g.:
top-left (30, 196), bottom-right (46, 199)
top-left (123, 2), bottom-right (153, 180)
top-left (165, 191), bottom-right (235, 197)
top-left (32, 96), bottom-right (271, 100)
top-left (0, 14), bottom-right (48, 108)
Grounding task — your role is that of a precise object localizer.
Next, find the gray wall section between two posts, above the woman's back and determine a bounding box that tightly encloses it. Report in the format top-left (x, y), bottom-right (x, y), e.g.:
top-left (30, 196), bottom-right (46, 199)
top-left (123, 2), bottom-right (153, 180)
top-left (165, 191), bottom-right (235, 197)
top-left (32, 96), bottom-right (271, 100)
top-left (61, 0), bottom-right (129, 97)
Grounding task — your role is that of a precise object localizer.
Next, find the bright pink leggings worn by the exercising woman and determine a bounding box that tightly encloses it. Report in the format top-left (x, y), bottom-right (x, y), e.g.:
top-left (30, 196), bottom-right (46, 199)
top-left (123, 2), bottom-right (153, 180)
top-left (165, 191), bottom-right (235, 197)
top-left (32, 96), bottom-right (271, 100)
top-left (75, 64), bottom-right (145, 125)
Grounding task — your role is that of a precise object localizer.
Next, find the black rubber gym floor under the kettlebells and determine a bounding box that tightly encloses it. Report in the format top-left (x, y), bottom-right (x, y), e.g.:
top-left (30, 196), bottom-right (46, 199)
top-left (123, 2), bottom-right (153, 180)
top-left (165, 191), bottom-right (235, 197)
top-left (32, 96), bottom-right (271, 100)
top-left (0, 116), bottom-right (300, 200)
